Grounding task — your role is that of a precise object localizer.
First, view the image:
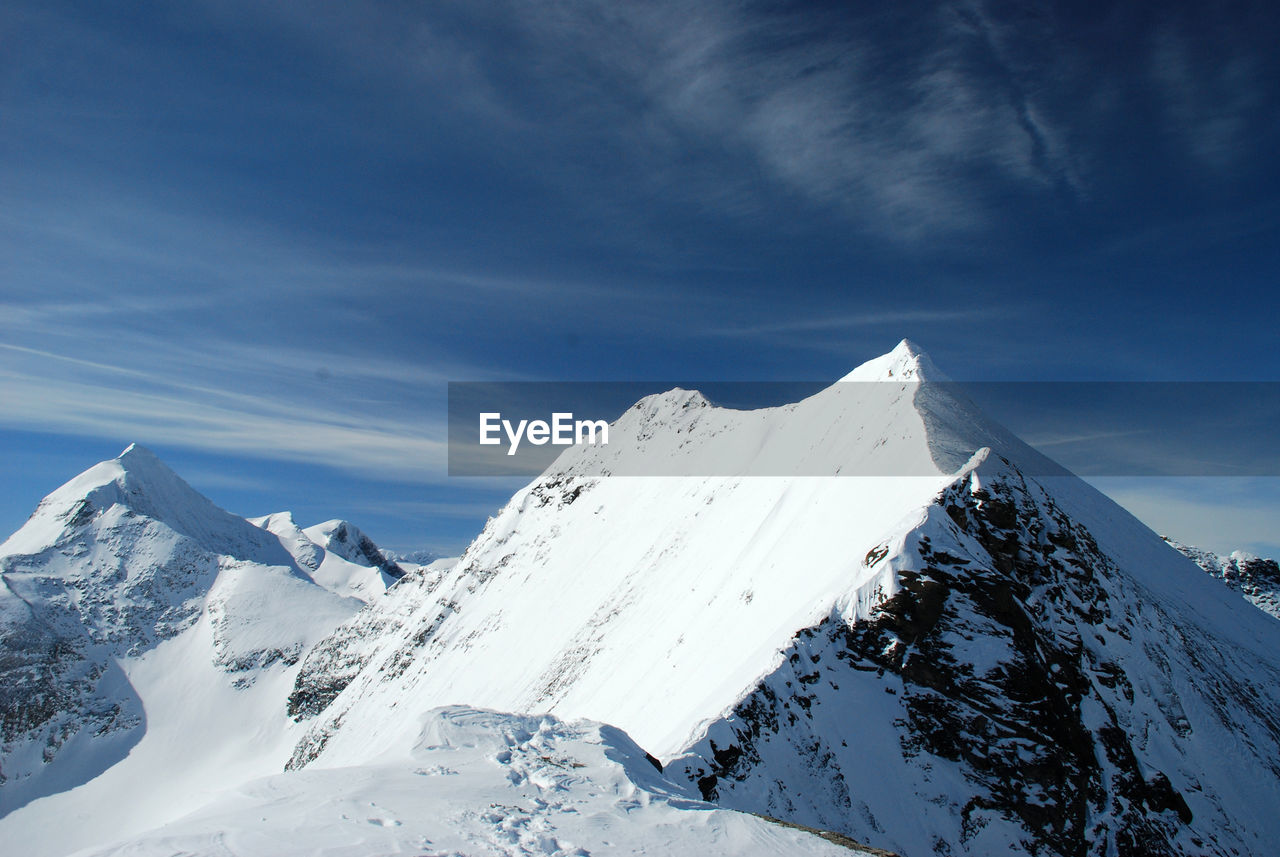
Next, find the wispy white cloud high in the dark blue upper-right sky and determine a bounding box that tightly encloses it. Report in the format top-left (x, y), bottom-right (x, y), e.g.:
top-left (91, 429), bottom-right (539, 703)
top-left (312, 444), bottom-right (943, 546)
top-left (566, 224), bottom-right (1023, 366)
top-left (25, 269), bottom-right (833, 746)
top-left (591, 0), bottom-right (1070, 240)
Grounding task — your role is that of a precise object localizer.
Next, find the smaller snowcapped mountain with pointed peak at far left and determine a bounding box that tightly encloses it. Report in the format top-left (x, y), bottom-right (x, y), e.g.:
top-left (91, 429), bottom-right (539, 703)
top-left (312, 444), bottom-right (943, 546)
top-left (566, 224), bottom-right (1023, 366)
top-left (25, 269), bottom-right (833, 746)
top-left (0, 445), bottom-right (399, 844)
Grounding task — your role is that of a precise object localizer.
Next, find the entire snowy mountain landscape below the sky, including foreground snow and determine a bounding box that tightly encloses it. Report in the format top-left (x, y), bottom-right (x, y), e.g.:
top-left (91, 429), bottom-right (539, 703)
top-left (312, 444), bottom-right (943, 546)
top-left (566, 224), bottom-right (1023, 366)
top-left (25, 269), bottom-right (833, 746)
top-left (0, 343), bottom-right (1280, 857)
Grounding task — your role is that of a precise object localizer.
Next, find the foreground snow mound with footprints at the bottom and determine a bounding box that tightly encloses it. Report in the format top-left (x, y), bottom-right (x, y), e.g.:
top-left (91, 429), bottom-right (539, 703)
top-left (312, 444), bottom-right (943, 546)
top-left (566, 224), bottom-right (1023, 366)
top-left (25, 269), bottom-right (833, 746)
top-left (84, 707), bottom-right (867, 857)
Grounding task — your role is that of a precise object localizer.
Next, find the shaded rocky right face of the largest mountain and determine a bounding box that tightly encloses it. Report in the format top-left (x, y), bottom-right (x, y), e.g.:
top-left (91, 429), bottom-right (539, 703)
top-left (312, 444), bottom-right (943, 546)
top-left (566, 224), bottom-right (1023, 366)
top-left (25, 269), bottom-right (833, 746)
top-left (667, 452), bottom-right (1280, 856)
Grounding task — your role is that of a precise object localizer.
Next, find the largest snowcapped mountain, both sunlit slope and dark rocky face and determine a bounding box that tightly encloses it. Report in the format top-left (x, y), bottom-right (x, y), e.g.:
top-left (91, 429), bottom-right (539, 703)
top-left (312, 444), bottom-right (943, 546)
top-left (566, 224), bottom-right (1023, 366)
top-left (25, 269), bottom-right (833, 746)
top-left (289, 343), bottom-right (1280, 854)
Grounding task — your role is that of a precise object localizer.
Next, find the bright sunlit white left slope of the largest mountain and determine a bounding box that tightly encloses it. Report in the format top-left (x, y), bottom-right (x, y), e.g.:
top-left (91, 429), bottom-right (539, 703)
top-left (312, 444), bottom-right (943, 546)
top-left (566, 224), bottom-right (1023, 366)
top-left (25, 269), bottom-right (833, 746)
top-left (293, 345), bottom-right (967, 764)
